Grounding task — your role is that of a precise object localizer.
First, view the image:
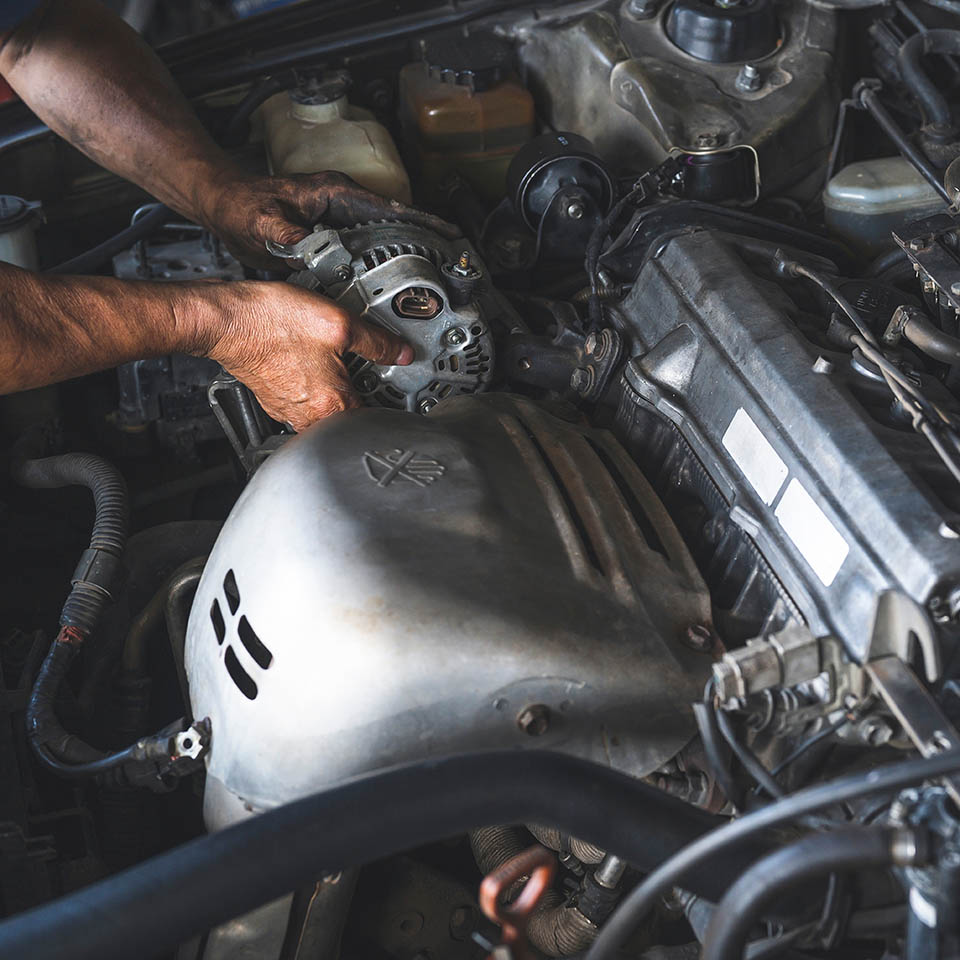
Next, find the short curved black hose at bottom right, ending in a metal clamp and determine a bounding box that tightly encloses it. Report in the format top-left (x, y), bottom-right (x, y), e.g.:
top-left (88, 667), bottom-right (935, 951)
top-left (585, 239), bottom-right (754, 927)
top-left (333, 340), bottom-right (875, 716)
top-left (703, 827), bottom-right (893, 960)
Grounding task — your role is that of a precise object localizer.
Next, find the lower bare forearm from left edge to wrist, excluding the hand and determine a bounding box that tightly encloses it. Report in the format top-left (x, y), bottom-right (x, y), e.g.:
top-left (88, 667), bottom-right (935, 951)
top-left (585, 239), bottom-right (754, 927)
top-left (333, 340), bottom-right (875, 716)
top-left (0, 263), bottom-right (218, 394)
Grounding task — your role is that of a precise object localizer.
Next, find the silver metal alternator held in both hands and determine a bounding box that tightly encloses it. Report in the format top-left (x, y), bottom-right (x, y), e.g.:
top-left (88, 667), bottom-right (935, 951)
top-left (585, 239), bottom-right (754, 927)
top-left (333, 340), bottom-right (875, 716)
top-left (270, 222), bottom-right (498, 413)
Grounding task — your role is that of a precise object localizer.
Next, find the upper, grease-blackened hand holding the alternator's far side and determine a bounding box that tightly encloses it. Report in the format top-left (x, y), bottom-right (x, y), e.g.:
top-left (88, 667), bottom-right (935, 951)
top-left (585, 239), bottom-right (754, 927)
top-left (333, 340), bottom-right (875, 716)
top-left (198, 171), bottom-right (460, 269)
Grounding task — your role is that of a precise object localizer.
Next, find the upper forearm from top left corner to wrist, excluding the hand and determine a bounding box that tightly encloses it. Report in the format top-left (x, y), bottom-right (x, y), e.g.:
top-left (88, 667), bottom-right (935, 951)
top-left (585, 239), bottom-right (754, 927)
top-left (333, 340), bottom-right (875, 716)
top-left (0, 0), bottom-right (239, 223)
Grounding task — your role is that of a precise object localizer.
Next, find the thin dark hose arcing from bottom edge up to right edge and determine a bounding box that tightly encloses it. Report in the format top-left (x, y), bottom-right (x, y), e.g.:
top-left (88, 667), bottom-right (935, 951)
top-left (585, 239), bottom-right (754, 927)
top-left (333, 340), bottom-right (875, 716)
top-left (587, 750), bottom-right (960, 960)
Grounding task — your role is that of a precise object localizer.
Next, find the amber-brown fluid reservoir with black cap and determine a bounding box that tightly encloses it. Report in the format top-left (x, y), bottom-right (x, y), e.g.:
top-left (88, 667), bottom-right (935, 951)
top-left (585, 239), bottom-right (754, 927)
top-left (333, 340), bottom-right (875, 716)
top-left (400, 33), bottom-right (534, 200)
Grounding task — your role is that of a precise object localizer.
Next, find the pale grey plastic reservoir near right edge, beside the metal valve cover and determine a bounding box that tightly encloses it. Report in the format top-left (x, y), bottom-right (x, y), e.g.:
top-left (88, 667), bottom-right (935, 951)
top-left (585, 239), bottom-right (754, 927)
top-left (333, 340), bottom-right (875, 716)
top-left (823, 157), bottom-right (946, 254)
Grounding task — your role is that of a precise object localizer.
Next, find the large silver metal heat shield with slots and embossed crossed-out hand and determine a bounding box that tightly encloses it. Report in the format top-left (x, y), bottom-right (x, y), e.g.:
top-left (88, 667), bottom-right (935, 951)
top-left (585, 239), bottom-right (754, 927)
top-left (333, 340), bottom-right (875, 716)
top-left (186, 395), bottom-right (711, 828)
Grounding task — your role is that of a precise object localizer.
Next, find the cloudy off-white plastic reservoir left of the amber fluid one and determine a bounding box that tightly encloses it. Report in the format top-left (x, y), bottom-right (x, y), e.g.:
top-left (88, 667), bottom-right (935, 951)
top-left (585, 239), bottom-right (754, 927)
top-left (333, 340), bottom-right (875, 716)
top-left (261, 71), bottom-right (411, 203)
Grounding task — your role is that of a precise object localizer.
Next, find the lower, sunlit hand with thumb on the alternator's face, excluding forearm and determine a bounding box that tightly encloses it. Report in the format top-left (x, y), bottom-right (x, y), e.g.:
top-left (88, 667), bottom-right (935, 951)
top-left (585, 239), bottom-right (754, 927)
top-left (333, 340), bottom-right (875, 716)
top-left (203, 281), bottom-right (413, 430)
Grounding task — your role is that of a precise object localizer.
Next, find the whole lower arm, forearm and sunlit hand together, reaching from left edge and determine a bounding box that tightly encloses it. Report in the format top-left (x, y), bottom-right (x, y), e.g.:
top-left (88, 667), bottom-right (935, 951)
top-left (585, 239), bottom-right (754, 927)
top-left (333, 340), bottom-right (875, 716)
top-left (0, 263), bottom-right (413, 429)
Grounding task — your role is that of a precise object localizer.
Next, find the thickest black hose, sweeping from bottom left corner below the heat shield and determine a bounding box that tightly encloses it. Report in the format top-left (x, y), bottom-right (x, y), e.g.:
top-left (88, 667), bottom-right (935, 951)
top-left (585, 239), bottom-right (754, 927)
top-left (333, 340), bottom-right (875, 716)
top-left (0, 750), bottom-right (775, 960)
